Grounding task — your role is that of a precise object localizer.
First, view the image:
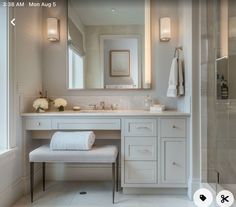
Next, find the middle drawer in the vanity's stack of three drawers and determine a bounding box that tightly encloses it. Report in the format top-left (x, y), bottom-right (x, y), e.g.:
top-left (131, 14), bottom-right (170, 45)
top-left (125, 137), bottom-right (157, 160)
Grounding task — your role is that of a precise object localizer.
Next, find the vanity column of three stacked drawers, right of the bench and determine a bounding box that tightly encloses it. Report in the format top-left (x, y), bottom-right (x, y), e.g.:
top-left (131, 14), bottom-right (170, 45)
top-left (124, 119), bottom-right (157, 187)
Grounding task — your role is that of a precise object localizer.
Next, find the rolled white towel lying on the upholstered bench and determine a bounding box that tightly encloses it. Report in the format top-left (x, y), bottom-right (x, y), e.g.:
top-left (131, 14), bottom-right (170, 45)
top-left (50, 131), bottom-right (95, 150)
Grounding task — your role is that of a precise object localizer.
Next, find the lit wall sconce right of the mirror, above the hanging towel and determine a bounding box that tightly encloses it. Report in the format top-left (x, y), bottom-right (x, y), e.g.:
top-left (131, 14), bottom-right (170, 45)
top-left (160, 17), bottom-right (171, 42)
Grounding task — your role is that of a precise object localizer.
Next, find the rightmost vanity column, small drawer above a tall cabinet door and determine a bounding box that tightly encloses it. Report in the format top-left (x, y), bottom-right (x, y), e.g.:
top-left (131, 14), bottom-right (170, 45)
top-left (159, 118), bottom-right (187, 187)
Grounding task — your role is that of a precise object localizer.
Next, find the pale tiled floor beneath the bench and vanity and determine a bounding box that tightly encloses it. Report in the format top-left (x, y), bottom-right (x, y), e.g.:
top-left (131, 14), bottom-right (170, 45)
top-left (13, 182), bottom-right (195, 207)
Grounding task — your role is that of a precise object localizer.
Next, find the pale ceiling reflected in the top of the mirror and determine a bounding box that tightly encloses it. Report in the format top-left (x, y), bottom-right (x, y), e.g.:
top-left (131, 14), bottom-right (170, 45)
top-left (69, 0), bottom-right (145, 25)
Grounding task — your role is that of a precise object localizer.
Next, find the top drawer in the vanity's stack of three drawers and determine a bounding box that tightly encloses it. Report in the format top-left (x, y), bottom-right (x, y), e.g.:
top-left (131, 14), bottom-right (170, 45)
top-left (125, 119), bottom-right (157, 136)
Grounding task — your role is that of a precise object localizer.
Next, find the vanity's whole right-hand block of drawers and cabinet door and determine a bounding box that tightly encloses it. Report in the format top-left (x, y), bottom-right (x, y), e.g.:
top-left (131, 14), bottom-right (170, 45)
top-left (123, 117), bottom-right (188, 188)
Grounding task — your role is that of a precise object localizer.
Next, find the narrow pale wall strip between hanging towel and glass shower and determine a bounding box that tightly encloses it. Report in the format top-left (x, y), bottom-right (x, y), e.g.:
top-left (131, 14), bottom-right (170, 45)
top-left (178, 0), bottom-right (201, 197)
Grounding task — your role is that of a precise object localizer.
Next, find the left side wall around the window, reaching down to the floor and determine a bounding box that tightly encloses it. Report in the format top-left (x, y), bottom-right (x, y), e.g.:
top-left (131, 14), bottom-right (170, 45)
top-left (0, 5), bottom-right (42, 207)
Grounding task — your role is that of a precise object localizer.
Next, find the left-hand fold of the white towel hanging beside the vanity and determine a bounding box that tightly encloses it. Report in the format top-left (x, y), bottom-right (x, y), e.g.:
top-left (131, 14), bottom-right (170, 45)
top-left (167, 57), bottom-right (178, 97)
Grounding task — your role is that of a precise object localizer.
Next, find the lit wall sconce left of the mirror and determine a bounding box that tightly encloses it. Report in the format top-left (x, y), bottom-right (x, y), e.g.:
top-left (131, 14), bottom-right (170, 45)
top-left (47, 18), bottom-right (60, 42)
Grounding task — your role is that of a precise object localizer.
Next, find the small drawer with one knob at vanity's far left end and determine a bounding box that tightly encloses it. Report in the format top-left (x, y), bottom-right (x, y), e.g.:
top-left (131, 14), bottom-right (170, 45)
top-left (25, 118), bottom-right (52, 130)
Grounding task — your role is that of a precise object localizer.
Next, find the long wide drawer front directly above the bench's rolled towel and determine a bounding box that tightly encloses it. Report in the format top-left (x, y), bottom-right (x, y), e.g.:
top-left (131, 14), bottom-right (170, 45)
top-left (52, 118), bottom-right (121, 130)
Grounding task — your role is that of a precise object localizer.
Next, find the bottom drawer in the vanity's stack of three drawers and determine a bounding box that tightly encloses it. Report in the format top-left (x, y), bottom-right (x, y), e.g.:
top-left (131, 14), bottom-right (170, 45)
top-left (125, 161), bottom-right (157, 184)
